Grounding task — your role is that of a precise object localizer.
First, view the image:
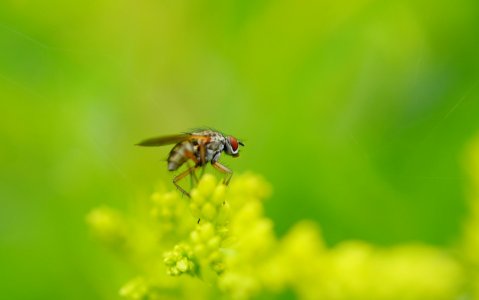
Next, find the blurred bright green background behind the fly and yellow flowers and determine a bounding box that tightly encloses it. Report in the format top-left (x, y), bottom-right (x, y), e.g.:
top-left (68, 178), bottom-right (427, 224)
top-left (0, 0), bottom-right (479, 299)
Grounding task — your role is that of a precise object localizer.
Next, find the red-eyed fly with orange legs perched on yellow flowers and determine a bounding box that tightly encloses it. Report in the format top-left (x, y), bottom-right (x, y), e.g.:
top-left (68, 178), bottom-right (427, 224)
top-left (137, 129), bottom-right (244, 197)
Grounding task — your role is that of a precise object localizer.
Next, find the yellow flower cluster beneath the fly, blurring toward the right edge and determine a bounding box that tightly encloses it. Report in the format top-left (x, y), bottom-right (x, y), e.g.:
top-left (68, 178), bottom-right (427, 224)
top-left (87, 137), bottom-right (479, 300)
